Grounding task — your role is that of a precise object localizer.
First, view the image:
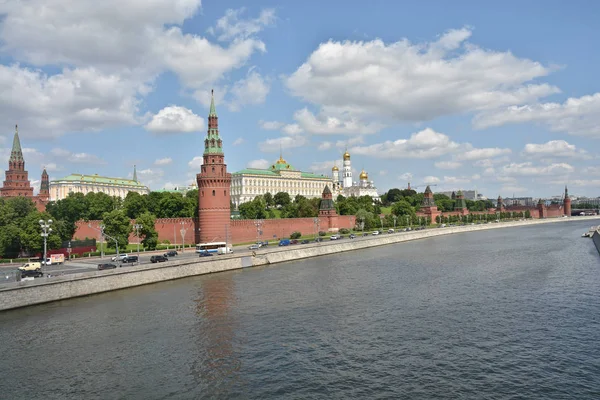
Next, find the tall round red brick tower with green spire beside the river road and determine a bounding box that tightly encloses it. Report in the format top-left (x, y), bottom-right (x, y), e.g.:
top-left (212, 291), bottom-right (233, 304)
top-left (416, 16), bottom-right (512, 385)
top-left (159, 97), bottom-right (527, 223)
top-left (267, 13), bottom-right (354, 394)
top-left (196, 91), bottom-right (231, 243)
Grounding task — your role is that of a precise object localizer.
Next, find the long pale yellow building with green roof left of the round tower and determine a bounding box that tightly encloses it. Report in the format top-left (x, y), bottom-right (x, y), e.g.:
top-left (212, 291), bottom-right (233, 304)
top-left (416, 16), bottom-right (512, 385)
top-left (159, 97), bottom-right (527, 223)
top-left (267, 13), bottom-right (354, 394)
top-left (50, 166), bottom-right (150, 201)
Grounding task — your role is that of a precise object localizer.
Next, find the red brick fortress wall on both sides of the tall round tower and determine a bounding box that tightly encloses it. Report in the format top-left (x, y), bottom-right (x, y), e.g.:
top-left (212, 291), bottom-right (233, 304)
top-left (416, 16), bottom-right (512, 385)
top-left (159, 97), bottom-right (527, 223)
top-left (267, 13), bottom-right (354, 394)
top-left (73, 215), bottom-right (355, 244)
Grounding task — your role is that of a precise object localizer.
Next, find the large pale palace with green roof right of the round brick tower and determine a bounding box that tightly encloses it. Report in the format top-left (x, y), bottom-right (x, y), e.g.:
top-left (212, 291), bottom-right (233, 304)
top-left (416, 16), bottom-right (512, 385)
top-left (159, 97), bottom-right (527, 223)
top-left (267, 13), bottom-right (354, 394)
top-left (231, 156), bottom-right (331, 208)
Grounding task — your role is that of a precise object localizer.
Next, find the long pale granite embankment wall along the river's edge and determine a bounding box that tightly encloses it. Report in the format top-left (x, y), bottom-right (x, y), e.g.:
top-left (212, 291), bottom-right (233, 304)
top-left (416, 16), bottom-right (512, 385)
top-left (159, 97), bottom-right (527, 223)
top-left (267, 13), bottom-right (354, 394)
top-left (0, 216), bottom-right (600, 310)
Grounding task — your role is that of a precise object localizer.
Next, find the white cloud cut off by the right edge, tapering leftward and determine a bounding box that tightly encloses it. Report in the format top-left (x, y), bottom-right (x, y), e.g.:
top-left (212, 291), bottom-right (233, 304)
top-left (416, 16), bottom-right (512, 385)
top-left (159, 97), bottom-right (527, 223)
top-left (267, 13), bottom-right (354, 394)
top-left (474, 93), bottom-right (600, 137)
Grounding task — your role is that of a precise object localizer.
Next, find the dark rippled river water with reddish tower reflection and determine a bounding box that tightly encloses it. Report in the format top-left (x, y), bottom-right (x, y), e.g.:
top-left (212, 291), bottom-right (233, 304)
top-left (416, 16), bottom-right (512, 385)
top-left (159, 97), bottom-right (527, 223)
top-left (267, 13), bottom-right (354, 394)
top-left (0, 222), bottom-right (600, 399)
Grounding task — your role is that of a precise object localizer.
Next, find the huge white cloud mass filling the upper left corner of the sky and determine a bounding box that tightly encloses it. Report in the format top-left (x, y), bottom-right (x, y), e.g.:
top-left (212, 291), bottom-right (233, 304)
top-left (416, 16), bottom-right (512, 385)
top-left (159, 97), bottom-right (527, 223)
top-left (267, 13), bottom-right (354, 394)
top-left (0, 0), bottom-right (266, 137)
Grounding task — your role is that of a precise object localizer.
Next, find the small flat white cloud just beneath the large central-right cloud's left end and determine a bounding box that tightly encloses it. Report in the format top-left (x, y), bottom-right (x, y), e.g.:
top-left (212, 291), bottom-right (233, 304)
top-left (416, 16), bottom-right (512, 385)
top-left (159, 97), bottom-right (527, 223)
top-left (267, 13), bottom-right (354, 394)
top-left (294, 108), bottom-right (384, 135)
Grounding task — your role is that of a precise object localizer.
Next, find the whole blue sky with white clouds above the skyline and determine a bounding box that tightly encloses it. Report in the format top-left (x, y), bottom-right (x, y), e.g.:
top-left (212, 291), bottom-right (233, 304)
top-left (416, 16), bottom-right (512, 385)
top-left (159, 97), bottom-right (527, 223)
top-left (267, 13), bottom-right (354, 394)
top-left (0, 0), bottom-right (600, 198)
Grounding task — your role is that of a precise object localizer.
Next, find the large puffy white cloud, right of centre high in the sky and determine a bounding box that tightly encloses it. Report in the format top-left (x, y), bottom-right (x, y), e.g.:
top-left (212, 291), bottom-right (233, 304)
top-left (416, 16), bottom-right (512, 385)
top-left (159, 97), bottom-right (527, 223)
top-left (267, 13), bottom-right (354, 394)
top-left (285, 28), bottom-right (559, 121)
